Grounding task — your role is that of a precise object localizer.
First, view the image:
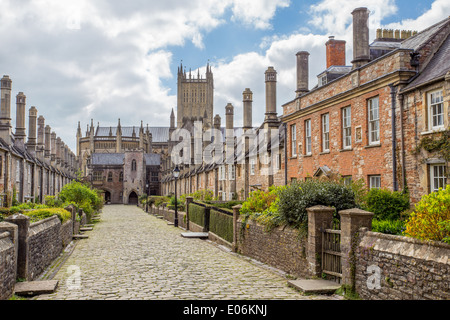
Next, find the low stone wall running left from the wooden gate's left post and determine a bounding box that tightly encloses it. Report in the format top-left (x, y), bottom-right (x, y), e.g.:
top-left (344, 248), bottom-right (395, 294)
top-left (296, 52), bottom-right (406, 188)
top-left (235, 219), bottom-right (312, 277)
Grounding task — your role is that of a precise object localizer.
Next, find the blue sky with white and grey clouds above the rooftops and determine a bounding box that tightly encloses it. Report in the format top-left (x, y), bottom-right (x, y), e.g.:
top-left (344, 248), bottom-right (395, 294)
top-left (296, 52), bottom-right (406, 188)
top-left (0, 0), bottom-right (450, 152)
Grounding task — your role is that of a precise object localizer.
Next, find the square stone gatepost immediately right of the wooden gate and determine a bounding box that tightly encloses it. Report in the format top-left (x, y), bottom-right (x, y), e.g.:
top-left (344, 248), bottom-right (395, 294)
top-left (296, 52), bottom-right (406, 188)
top-left (339, 208), bottom-right (373, 288)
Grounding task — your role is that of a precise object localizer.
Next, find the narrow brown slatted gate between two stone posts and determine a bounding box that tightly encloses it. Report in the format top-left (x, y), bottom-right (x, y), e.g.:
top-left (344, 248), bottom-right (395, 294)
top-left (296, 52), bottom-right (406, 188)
top-left (322, 222), bottom-right (342, 283)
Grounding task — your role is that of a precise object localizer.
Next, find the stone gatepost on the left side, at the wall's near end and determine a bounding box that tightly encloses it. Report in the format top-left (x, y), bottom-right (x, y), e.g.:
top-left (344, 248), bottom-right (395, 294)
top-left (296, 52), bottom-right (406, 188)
top-left (5, 214), bottom-right (30, 280)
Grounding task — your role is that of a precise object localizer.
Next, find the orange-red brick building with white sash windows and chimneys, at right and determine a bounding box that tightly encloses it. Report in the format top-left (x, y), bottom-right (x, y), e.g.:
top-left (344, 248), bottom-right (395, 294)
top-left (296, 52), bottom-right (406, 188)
top-left (281, 8), bottom-right (450, 201)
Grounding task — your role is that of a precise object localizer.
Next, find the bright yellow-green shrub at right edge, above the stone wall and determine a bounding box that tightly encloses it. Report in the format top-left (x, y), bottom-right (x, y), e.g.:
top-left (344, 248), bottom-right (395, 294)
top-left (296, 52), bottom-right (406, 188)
top-left (404, 187), bottom-right (450, 241)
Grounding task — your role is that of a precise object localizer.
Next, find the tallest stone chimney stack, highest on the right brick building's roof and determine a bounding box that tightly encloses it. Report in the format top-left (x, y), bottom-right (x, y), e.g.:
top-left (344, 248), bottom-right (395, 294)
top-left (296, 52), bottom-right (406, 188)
top-left (352, 8), bottom-right (370, 69)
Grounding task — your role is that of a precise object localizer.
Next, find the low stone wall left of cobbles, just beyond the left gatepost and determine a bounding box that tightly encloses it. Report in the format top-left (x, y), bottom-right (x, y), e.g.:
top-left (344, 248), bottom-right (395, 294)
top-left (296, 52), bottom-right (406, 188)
top-left (27, 216), bottom-right (63, 280)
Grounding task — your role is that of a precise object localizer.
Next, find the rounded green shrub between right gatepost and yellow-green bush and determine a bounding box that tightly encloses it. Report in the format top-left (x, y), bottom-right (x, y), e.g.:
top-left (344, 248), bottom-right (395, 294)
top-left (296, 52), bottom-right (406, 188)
top-left (365, 189), bottom-right (409, 220)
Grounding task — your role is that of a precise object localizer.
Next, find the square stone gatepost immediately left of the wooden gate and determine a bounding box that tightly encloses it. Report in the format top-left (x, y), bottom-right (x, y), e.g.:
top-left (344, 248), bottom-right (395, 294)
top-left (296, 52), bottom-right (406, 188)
top-left (306, 206), bottom-right (335, 276)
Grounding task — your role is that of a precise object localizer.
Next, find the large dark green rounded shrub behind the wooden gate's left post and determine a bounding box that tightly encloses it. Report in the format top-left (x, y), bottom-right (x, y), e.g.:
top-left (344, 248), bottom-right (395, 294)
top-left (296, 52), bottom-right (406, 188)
top-left (277, 180), bottom-right (357, 227)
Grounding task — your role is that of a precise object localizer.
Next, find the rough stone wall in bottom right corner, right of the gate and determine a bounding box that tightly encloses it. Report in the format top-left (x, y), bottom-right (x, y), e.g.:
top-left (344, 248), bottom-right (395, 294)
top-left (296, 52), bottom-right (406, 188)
top-left (355, 229), bottom-right (450, 300)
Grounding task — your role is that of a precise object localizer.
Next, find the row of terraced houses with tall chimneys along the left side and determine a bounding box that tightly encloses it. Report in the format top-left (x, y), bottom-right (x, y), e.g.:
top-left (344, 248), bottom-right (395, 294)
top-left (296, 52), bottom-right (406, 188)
top-left (0, 75), bottom-right (78, 207)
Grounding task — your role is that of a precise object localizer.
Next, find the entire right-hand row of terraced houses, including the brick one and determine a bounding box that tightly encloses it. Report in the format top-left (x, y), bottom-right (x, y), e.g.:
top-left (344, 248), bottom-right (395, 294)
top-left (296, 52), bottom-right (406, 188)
top-left (161, 8), bottom-right (450, 202)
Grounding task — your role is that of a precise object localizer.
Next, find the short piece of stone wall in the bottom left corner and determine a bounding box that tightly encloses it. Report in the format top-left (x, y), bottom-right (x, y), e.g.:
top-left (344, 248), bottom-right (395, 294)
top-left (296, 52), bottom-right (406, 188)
top-left (0, 232), bottom-right (17, 300)
